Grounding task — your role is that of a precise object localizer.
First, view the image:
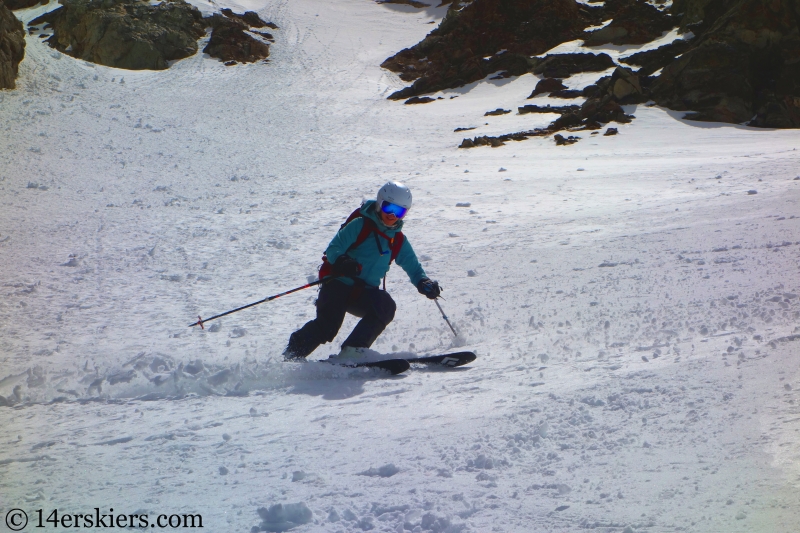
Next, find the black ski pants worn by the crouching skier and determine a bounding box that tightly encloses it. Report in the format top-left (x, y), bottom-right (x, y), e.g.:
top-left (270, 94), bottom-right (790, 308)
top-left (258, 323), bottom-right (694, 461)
top-left (284, 280), bottom-right (397, 358)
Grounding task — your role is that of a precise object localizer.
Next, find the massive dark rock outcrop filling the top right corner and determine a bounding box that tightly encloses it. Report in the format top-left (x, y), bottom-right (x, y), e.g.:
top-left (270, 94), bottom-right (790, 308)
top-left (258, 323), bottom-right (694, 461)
top-left (650, 0), bottom-right (800, 128)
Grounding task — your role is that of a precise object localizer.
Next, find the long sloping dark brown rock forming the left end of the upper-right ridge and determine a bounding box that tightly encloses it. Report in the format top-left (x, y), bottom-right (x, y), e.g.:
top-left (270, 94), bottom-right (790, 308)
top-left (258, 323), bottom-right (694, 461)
top-left (381, 0), bottom-right (596, 99)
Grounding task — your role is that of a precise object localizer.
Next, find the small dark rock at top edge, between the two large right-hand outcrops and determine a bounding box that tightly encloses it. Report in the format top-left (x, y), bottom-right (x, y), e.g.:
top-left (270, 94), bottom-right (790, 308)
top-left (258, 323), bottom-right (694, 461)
top-left (584, 0), bottom-right (677, 46)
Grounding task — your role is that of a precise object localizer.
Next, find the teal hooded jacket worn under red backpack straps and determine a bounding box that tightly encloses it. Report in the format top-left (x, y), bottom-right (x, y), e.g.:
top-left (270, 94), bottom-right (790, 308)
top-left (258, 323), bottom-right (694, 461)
top-left (325, 200), bottom-right (428, 287)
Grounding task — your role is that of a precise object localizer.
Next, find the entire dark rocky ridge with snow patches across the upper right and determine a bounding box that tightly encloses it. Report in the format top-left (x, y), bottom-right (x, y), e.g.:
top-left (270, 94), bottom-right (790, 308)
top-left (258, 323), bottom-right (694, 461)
top-left (381, 0), bottom-right (800, 141)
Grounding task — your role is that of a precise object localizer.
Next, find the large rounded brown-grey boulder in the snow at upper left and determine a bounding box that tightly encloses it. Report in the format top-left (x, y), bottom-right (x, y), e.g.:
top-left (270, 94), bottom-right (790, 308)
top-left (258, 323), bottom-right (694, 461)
top-left (30, 0), bottom-right (205, 70)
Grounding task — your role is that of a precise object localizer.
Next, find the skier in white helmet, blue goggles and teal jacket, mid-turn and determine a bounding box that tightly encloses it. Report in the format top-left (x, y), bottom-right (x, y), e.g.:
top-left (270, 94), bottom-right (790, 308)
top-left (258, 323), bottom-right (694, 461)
top-left (283, 181), bottom-right (441, 361)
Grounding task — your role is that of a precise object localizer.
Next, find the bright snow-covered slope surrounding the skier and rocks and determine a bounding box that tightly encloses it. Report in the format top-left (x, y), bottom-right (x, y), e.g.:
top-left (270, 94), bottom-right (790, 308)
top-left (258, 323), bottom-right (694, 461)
top-left (0, 0), bottom-right (800, 533)
